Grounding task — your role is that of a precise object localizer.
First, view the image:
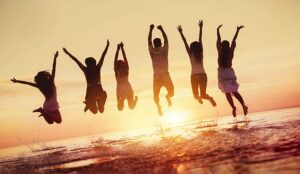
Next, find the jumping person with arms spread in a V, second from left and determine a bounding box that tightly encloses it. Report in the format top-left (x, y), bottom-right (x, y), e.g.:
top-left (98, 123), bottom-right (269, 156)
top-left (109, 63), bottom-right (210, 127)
top-left (63, 40), bottom-right (109, 114)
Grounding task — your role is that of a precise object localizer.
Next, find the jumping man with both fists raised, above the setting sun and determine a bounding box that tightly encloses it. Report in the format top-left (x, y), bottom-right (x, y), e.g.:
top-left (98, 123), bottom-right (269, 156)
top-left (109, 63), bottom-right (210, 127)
top-left (148, 24), bottom-right (174, 115)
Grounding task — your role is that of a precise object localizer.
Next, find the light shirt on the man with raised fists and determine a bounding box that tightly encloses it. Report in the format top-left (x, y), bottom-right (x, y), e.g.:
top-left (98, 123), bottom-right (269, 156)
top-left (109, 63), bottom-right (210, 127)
top-left (149, 43), bottom-right (169, 75)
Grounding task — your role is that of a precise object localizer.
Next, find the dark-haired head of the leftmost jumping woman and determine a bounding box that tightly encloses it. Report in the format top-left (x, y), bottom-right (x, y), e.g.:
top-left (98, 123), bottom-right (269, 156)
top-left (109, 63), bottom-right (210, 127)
top-left (34, 71), bottom-right (53, 97)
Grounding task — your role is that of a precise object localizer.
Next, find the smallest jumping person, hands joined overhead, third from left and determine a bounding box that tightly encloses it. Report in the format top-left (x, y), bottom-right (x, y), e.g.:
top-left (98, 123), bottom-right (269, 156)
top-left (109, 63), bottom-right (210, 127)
top-left (114, 42), bottom-right (138, 111)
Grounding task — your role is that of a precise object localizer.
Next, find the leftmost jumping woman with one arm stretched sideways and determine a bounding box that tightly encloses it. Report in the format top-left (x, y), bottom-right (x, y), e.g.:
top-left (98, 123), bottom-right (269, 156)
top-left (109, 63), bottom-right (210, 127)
top-left (11, 51), bottom-right (62, 124)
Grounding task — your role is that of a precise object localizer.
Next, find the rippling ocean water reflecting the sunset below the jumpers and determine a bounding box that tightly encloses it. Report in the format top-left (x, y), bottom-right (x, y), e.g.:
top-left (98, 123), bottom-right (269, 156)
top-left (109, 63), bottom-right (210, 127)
top-left (0, 107), bottom-right (300, 174)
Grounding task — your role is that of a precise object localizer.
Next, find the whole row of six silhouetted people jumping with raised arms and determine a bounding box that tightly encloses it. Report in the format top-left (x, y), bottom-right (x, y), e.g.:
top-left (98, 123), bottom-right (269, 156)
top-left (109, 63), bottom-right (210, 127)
top-left (11, 20), bottom-right (248, 124)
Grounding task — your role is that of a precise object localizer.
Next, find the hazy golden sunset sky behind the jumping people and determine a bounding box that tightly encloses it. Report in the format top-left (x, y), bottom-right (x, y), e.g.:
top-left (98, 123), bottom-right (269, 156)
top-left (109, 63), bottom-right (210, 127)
top-left (0, 0), bottom-right (300, 147)
